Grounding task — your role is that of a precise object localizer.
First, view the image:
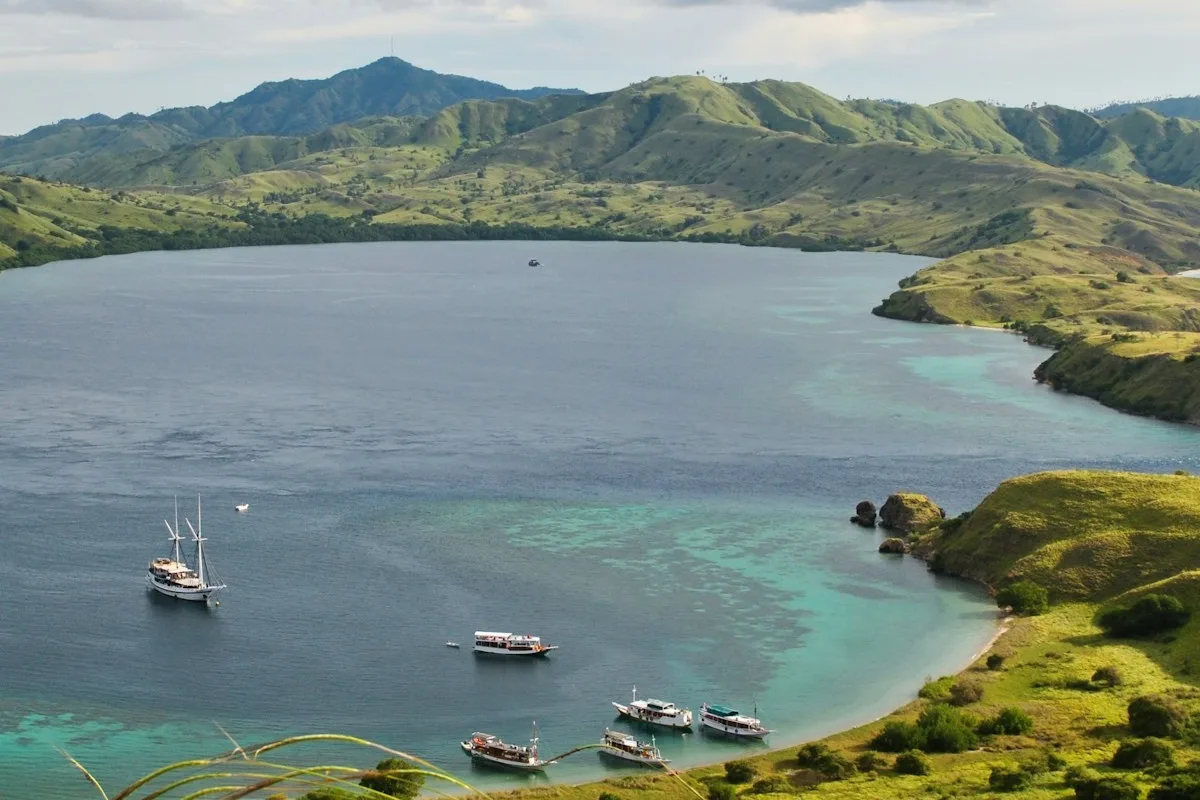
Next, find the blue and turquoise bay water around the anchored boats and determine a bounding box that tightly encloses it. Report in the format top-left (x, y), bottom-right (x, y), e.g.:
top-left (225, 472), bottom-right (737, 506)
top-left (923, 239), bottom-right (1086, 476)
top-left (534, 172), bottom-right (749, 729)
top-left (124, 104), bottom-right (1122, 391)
top-left (0, 242), bottom-right (1200, 800)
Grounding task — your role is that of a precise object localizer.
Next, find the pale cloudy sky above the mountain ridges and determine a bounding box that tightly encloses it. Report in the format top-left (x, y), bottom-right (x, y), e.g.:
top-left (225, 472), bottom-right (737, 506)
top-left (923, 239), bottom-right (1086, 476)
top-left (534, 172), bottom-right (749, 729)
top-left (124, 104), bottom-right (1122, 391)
top-left (0, 0), bottom-right (1200, 133)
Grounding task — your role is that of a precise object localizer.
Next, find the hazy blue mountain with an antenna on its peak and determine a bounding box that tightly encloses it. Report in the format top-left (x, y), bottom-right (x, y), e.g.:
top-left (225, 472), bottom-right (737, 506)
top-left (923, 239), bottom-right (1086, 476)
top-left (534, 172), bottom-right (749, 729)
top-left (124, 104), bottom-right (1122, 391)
top-left (0, 58), bottom-right (581, 178)
